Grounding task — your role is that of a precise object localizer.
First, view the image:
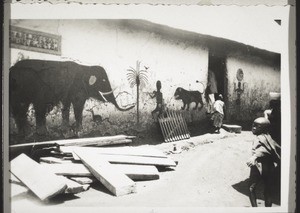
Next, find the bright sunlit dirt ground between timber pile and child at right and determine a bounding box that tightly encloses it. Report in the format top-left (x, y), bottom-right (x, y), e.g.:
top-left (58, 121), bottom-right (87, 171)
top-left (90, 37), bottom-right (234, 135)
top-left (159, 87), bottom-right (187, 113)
top-left (11, 129), bottom-right (279, 212)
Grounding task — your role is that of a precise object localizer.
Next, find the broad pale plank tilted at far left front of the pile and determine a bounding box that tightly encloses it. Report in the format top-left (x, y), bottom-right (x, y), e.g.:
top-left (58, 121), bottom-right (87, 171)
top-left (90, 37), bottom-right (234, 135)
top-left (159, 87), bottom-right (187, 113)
top-left (10, 154), bottom-right (67, 200)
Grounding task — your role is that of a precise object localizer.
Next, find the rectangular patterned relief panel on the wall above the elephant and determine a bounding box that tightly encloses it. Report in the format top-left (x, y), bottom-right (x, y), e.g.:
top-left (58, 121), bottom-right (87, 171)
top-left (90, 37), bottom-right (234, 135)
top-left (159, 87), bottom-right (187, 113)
top-left (9, 26), bottom-right (61, 55)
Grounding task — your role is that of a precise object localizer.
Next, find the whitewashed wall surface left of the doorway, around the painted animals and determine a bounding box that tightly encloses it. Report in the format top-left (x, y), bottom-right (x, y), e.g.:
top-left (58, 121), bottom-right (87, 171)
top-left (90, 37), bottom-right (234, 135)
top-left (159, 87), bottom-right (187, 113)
top-left (11, 20), bottom-right (208, 134)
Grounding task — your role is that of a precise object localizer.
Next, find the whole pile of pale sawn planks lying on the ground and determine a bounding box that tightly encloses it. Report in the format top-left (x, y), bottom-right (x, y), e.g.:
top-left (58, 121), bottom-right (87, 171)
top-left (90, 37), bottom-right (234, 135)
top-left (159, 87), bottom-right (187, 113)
top-left (10, 135), bottom-right (177, 201)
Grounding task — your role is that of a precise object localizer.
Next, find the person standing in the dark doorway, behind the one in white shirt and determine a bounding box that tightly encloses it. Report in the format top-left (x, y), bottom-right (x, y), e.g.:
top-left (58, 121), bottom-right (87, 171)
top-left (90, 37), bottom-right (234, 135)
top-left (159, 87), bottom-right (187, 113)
top-left (205, 70), bottom-right (218, 114)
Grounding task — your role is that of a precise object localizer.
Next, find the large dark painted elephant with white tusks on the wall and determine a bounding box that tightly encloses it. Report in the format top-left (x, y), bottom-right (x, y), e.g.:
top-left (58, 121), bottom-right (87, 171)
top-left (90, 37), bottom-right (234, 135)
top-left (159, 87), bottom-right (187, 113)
top-left (9, 60), bottom-right (134, 133)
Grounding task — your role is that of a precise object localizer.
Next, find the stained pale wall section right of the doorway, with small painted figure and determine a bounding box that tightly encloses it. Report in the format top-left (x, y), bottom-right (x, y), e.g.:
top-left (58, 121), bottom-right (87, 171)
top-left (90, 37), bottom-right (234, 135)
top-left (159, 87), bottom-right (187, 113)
top-left (227, 56), bottom-right (280, 121)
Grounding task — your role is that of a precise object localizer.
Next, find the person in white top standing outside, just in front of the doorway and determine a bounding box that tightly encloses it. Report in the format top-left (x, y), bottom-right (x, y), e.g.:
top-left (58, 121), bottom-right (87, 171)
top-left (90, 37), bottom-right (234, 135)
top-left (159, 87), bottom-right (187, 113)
top-left (211, 94), bottom-right (225, 134)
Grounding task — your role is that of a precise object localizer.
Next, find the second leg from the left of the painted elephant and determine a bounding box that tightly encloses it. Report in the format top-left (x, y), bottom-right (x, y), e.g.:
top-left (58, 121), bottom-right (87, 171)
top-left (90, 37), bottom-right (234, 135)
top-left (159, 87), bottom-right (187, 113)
top-left (34, 103), bottom-right (47, 135)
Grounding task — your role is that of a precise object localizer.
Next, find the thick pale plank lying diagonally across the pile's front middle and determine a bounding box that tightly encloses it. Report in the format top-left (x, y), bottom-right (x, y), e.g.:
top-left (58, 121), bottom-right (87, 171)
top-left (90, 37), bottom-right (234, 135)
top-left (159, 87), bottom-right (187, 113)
top-left (75, 150), bottom-right (136, 196)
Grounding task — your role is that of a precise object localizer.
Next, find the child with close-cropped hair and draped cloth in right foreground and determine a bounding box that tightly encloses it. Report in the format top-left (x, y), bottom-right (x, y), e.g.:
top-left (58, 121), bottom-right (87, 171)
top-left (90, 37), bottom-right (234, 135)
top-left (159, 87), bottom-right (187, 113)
top-left (247, 117), bottom-right (280, 207)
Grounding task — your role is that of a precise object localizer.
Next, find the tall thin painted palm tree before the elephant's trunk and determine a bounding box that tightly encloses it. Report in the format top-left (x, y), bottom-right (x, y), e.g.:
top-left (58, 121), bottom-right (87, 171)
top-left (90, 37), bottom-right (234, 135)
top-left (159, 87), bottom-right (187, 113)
top-left (127, 61), bottom-right (148, 123)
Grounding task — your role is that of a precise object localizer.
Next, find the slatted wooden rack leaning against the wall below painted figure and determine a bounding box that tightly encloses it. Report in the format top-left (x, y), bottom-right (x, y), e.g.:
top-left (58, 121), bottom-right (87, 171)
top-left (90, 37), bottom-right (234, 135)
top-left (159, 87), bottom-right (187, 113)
top-left (158, 111), bottom-right (191, 142)
